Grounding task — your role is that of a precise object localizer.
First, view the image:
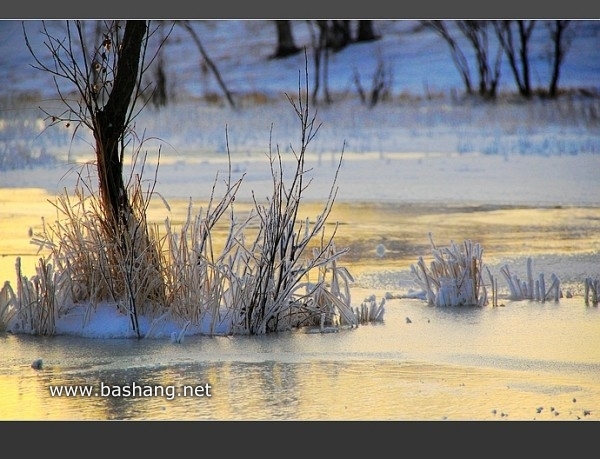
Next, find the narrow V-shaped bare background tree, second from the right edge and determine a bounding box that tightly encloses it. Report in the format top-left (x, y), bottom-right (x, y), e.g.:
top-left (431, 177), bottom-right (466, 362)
top-left (494, 20), bottom-right (536, 97)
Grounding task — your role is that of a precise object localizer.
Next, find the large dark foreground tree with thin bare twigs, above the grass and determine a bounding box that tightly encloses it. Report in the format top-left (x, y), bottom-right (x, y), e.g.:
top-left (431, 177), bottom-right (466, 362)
top-left (23, 21), bottom-right (148, 230)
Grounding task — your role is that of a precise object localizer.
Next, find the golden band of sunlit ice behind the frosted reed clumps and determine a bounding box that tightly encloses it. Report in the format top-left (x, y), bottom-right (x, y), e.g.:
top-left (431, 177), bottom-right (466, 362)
top-left (0, 188), bottom-right (600, 280)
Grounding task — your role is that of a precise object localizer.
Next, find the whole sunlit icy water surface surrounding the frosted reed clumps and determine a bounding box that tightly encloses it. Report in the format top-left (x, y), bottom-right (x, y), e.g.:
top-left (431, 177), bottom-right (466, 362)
top-left (0, 189), bottom-right (600, 420)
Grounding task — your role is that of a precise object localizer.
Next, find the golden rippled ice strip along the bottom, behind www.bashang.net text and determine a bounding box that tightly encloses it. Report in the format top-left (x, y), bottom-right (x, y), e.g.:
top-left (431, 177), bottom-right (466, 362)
top-left (0, 360), bottom-right (600, 420)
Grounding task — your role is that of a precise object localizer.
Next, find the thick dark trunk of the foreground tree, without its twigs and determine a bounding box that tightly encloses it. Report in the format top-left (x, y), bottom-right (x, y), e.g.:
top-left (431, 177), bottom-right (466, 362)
top-left (94, 21), bottom-right (147, 228)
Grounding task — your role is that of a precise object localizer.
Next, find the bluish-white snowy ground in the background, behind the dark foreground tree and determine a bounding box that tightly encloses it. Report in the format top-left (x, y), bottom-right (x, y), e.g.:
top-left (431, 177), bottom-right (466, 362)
top-left (0, 20), bottom-right (600, 204)
